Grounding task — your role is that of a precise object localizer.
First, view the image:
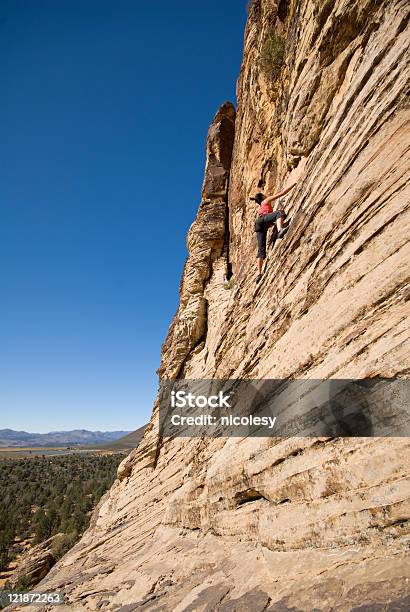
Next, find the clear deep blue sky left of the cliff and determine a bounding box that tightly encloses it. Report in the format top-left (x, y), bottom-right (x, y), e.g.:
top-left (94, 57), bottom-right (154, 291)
top-left (0, 0), bottom-right (246, 432)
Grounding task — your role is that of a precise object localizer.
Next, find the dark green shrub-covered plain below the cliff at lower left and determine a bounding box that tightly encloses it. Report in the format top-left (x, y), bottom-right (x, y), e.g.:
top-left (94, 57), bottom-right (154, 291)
top-left (0, 453), bottom-right (124, 571)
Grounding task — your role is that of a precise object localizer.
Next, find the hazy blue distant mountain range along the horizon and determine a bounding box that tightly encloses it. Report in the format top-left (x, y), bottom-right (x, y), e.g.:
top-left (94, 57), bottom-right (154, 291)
top-left (0, 429), bottom-right (131, 448)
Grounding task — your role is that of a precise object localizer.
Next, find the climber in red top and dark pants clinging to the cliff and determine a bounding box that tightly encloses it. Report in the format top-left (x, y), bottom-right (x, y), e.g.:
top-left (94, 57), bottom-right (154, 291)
top-left (251, 183), bottom-right (296, 283)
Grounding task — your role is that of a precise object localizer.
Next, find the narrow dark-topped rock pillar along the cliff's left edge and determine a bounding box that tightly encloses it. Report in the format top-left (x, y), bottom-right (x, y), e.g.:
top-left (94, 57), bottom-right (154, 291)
top-left (158, 102), bottom-right (235, 378)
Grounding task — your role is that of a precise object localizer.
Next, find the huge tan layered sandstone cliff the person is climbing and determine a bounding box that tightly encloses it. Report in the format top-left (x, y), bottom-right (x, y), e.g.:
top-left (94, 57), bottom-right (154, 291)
top-left (20, 0), bottom-right (410, 612)
